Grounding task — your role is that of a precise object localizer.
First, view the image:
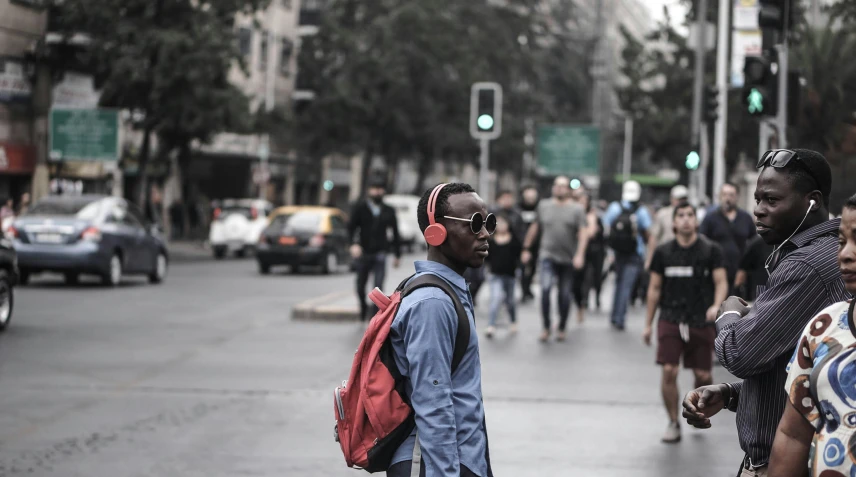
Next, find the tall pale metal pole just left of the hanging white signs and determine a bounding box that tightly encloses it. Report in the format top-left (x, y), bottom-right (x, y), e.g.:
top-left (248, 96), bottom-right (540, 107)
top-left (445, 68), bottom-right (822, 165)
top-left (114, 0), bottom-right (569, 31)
top-left (713, 0), bottom-right (732, 201)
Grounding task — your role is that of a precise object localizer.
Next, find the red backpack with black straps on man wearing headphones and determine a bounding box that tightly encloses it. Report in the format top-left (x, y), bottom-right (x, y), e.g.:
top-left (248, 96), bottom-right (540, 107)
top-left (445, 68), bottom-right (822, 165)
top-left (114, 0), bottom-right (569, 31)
top-left (333, 274), bottom-right (470, 472)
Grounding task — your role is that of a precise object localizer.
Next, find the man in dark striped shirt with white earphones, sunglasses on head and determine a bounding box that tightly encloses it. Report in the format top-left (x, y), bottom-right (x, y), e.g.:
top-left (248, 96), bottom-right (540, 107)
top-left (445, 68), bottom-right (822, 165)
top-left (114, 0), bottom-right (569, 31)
top-left (683, 149), bottom-right (848, 477)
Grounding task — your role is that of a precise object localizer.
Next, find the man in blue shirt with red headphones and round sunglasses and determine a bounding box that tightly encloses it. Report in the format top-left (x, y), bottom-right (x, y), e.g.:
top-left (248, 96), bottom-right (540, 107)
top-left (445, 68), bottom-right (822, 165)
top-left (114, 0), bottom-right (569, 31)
top-left (387, 183), bottom-right (496, 477)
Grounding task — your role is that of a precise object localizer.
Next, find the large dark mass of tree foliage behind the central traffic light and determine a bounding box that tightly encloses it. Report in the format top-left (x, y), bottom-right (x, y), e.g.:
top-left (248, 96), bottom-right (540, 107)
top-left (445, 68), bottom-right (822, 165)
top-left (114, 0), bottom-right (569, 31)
top-left (297, 0), bottom-right (587, 193)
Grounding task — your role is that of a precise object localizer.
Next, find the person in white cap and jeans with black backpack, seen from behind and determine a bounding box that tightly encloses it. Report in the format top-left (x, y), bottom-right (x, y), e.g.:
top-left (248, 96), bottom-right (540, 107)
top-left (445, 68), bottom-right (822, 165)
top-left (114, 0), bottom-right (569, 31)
top-left (603, 181), bottom-right (651, 330)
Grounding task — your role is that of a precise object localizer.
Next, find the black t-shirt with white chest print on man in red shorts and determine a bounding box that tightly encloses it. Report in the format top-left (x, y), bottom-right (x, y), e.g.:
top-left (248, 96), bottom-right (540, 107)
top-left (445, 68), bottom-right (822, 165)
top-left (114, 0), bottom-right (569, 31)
top-left (651, 236), bottom-right (725, 326)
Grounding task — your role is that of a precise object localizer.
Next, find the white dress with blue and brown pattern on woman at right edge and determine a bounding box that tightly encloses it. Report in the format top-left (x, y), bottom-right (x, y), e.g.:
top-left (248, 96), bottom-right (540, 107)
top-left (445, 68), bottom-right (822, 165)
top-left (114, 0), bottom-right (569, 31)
top-left (785, 301), bottom-right (856, 477)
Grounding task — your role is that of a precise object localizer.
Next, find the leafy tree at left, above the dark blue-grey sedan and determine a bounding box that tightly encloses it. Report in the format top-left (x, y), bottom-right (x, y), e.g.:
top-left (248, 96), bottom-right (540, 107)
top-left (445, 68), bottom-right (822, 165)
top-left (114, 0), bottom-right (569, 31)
top-left (53, 0), bottom-right (267, 204)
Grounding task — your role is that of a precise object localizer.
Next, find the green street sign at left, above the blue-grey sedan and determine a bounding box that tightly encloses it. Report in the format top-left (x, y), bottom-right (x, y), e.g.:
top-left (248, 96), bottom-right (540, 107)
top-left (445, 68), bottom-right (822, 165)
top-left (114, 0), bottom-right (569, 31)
top-left (48, 109), bottom-right (119, 161)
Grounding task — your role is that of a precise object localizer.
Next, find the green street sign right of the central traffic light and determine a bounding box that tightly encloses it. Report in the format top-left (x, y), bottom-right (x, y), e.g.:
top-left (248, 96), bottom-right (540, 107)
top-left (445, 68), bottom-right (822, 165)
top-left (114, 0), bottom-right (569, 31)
top-left (538, 124), bottom-right (600, 175)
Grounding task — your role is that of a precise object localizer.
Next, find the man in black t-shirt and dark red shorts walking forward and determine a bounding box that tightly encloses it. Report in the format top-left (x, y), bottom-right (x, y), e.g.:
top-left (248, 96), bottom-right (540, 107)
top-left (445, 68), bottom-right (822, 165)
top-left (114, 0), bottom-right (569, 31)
top-left (642, 202), bottom-right (728, 443)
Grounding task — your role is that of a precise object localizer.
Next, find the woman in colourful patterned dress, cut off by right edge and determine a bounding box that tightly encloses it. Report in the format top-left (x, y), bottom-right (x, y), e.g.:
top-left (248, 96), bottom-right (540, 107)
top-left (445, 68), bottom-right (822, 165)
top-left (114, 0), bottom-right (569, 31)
top-left (769, 195), bottom-right (856, 477)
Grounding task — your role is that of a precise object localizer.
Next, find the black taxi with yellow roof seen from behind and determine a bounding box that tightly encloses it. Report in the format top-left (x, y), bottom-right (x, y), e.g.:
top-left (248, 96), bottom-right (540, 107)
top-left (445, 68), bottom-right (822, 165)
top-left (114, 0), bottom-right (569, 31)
top-left (256, 206), bottom-right (350, 274)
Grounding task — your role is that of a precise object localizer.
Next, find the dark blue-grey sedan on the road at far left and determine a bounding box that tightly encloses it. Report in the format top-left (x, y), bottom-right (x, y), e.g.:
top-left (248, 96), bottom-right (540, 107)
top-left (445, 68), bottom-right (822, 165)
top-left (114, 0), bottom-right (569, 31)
top-left (6, 196), bottom-right (168, 286)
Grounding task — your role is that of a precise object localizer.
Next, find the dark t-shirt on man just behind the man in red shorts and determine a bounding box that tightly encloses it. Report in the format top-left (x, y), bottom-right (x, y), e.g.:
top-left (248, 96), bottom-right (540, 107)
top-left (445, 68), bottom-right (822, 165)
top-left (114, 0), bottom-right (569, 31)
top-left (699, 208), bottom-right (758, 283)
